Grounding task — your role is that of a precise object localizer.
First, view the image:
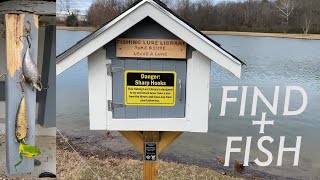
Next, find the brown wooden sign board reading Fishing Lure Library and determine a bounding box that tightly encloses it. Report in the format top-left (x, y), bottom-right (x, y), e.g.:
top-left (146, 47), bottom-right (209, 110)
top-left (116, 38), bottom-right (187, 59)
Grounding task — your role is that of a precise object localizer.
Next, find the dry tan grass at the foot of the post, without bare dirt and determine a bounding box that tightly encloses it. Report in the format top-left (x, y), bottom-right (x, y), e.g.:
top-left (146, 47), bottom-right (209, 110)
top-left (57, 150), bottom-right (239, 180)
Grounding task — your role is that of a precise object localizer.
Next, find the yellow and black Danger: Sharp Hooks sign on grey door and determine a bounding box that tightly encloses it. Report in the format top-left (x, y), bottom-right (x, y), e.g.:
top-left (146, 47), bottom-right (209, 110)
top-left (124, 70), bottom-right (176, 106)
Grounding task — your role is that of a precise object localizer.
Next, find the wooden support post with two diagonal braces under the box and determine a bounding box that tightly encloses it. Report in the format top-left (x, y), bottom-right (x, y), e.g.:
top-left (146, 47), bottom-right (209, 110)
top-left (119, 131), bottom-right (183, 180)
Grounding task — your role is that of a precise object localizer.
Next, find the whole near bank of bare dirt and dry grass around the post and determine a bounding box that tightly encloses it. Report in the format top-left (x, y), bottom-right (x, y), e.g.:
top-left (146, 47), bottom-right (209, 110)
top-left (57, 132), bottom-right (260, 180)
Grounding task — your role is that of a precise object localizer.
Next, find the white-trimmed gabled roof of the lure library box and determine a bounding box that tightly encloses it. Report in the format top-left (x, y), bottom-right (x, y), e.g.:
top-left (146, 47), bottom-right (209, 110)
top-left (57, 0), bottom-right (244, 77)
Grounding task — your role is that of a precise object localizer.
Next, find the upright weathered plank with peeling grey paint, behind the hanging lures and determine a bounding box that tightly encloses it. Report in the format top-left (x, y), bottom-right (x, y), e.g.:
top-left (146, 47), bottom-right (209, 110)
top-left (5, 14), bottom-right (38, 174)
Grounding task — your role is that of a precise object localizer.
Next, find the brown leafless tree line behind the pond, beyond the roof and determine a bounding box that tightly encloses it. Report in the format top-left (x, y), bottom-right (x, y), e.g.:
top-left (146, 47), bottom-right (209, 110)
top-left (62, 0), bottom-right (320, 34)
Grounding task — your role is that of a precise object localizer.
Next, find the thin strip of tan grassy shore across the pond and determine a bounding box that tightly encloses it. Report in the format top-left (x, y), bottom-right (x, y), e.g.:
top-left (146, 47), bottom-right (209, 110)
top-left (57, 26), bottom-right (320, 40)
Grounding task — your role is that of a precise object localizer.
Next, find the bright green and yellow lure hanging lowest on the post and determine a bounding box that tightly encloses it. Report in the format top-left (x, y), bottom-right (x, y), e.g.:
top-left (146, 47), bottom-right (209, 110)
top-left (14, 142), bottom-right (41, 170)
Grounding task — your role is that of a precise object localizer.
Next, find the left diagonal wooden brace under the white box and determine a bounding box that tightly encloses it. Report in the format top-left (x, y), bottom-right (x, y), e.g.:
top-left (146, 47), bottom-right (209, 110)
top-left (119, 131), bottom-right (143, 154)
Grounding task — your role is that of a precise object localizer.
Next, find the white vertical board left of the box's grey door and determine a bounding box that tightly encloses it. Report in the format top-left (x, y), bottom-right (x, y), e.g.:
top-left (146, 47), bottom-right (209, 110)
top-left (88, 48), bottom-right (107, 130)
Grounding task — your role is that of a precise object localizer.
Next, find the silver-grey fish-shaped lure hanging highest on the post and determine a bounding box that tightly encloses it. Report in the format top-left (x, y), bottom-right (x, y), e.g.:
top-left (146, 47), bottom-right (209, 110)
top-left (20, 47), bottom-right (42, 91)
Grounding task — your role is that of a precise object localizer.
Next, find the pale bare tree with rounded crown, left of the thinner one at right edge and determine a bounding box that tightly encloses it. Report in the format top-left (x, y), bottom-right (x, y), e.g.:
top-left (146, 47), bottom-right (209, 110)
top-left (276, 0), bottom-right (295, 33)
